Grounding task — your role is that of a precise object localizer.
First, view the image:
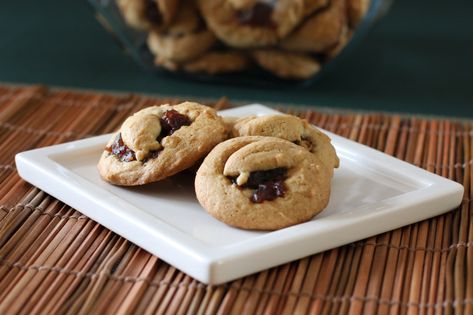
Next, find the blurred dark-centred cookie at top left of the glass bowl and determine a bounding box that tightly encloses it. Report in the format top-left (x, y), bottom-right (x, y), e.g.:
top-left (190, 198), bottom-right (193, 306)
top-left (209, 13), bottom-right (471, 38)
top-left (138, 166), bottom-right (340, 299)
top-left (117, 0), bottom-right (179, 30)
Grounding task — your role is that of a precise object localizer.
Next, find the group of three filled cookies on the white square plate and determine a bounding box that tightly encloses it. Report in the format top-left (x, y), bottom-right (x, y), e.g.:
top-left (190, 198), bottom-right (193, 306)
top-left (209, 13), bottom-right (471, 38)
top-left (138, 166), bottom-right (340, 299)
top-left (98, 102), bottom-right (339, 230)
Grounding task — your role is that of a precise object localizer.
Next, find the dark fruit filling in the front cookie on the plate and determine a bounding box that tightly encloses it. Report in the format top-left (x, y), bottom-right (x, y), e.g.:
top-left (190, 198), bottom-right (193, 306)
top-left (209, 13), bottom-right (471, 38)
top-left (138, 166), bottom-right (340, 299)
top-left (229, 167), bottom-right (287, 203)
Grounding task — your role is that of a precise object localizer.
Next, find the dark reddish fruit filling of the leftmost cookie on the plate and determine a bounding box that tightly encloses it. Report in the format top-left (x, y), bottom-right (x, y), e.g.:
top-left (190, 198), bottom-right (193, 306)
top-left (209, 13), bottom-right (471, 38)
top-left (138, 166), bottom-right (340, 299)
top-left (105, 109), bottom-right (192, 162)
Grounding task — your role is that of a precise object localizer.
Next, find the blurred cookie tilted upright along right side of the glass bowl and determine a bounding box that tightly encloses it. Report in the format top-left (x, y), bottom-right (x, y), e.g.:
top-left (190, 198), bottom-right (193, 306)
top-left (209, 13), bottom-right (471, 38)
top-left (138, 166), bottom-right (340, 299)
top-left (280, 0), bottom-right (346, 53)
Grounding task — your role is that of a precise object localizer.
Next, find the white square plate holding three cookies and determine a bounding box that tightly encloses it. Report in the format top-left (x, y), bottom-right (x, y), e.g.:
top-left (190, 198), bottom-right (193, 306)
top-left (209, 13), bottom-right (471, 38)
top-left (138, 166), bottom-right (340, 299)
top-left (16, 105), bottom-right (463, 284)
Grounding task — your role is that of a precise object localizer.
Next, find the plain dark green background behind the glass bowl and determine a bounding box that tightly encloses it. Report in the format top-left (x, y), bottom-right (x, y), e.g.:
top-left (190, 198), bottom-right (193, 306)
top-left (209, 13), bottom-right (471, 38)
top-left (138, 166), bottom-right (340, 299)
top-left (0, 0), bottom-right (473, 117)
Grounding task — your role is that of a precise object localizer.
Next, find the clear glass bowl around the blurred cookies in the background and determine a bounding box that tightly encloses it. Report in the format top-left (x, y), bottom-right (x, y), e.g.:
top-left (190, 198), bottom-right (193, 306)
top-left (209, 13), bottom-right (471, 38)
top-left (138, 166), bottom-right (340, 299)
top-left (89, 0), bottom-right (393, 87)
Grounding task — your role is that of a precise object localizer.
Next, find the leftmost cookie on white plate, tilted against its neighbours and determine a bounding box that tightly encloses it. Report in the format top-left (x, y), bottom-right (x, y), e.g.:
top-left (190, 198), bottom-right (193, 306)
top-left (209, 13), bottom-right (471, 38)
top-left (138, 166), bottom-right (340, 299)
top-left (98, 102), bottom-right (227, 186)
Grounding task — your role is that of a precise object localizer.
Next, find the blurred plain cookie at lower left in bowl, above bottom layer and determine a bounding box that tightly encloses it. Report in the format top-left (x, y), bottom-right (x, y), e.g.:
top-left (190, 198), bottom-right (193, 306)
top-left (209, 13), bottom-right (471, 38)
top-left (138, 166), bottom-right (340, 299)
top-left (147, 29), bottom-right (215, 62)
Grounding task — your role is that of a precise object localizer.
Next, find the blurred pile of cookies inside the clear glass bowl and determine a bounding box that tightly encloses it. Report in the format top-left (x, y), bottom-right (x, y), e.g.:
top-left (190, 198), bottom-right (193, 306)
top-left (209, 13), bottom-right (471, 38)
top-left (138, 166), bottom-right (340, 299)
top-left (117, 0), bottom-right (370, 79)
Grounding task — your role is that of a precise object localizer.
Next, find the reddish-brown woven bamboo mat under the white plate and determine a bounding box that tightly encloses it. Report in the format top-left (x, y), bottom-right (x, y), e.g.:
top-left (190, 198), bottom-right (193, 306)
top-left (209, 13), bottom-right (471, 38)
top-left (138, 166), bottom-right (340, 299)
top-left (0, 86), bottom-right (473, 314)
